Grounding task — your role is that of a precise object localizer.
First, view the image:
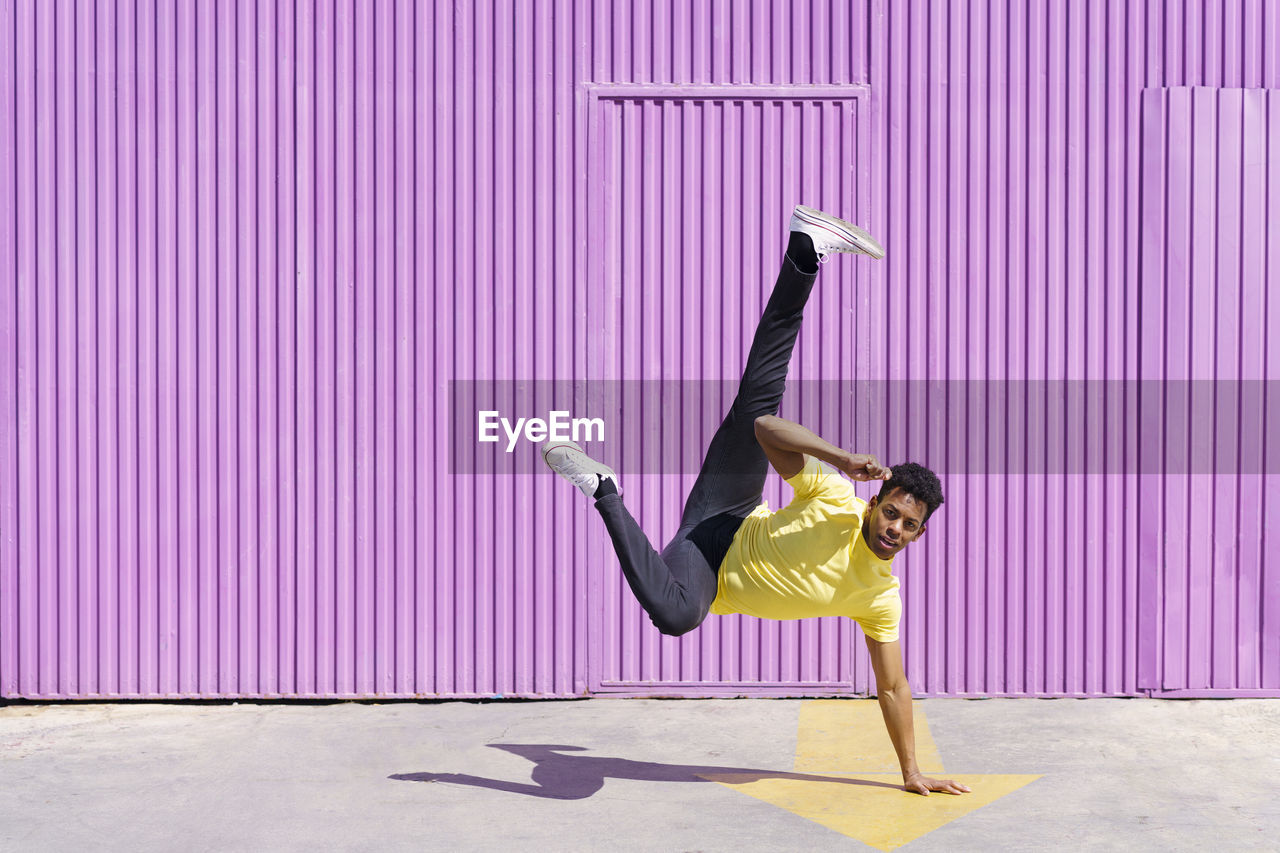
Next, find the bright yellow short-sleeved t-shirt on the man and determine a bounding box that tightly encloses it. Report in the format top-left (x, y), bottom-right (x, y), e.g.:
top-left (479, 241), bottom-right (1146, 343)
top-left (712, 455), bottom-right (902, 643)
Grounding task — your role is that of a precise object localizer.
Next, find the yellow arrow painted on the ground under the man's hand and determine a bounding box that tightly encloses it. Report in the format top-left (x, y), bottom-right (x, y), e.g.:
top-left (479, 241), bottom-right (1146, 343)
top-left (705, 699), bottom-right (1039, 850)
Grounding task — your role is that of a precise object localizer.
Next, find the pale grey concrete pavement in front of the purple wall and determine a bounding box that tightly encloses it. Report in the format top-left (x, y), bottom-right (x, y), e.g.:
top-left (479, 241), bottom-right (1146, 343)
top-left (0, 698), bottom-right (1280, 850)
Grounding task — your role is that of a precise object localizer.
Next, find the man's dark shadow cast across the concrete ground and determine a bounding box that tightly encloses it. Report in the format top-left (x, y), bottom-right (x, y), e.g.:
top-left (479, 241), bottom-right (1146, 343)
top-left (389, 743), bottom-right (901, 799)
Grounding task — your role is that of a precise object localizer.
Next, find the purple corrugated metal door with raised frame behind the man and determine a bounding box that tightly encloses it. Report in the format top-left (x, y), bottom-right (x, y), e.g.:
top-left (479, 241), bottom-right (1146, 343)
top-left (588, 86), bottom-right (874, 695)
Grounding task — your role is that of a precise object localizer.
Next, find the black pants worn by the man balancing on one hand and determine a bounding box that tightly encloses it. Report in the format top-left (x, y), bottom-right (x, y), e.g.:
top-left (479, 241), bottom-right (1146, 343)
top-left (595, 249), bottom-right (818, 637)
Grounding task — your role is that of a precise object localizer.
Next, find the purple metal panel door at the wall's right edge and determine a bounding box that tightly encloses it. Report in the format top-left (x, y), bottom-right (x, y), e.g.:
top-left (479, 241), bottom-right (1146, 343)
top-left (1138, 87), bottom-right (1280, 695)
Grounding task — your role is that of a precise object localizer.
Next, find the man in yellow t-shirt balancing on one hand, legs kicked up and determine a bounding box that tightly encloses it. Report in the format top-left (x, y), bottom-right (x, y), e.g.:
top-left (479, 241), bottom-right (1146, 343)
top-left (543, 205), bottom-right (969, 795)
